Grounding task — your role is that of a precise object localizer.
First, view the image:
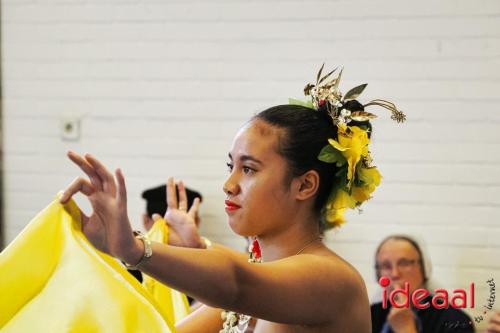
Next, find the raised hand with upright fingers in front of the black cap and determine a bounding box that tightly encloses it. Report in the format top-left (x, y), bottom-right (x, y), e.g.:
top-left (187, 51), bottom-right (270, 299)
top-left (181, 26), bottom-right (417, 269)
top-left (153, 178), bottom-right (204, 248)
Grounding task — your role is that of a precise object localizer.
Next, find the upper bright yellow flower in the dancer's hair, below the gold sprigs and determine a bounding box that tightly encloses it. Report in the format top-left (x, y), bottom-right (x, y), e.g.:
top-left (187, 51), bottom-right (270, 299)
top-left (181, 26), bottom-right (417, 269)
top-left (328, 123), bottom-right (370, 186)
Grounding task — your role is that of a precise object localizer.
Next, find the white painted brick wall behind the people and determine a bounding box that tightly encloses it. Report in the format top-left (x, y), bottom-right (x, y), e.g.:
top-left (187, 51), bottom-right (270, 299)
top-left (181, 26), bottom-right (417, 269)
top-left (1, 0), bottom-right (500, 327)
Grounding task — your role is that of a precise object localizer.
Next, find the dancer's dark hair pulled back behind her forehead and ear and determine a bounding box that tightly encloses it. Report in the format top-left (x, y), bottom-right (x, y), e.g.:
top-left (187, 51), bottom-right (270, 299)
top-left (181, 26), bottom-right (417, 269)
top-left (253, 105), bottom-right (337, 217)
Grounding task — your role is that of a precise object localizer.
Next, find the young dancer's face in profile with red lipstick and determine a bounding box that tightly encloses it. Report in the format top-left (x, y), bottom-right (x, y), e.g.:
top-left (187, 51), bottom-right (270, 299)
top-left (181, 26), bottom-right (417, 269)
top-left (224, 119), bottom-right (295, 236)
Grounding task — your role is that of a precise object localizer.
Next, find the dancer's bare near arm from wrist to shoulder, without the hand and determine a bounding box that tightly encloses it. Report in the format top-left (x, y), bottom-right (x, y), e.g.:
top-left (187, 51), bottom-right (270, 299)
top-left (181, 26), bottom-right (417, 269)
top-left (141, 243), bottom-right (366, 325)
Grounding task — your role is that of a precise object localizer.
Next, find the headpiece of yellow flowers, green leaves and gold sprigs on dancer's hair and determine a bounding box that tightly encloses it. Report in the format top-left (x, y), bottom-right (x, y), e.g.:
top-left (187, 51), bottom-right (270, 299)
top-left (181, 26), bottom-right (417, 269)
top-left (289, 64), bottom-right (406, 229)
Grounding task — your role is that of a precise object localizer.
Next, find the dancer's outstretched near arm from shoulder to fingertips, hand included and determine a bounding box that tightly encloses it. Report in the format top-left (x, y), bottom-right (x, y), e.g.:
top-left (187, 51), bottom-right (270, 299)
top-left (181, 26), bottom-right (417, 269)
top-left (61, 153), bottom-right (365, 324)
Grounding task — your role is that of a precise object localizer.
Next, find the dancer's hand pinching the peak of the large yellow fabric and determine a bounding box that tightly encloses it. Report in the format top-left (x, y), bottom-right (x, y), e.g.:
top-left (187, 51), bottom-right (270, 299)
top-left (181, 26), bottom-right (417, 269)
top-left (60, 151), bottom-right (143, 264)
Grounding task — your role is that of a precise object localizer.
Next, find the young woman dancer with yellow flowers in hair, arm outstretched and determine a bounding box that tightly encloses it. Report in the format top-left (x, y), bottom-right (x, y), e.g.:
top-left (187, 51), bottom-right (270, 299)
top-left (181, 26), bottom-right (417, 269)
top-left (61, 66), bottom-right (399, 333)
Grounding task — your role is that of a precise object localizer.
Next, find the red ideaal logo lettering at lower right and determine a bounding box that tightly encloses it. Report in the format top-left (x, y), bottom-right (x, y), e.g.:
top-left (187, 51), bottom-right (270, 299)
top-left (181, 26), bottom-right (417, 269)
top-left (379, 276), bottom-right (475, 309)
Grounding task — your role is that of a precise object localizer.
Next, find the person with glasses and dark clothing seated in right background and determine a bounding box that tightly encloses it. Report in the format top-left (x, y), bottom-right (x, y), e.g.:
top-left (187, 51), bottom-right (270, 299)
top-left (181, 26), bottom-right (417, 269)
top-left (371, 235), bottom-right (474, 333)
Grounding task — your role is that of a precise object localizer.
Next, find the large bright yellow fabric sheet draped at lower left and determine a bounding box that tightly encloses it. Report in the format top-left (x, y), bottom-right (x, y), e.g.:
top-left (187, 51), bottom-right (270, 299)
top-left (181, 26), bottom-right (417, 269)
top-left (0, 196), bottom-right (174, 333)
